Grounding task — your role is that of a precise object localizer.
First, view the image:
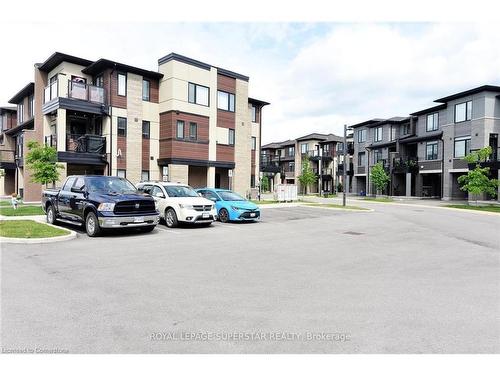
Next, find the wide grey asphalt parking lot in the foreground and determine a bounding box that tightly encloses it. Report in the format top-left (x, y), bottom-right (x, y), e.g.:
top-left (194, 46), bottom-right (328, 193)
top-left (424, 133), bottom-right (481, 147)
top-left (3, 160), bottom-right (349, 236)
top-left (1, 204), bottom-right (500, 353)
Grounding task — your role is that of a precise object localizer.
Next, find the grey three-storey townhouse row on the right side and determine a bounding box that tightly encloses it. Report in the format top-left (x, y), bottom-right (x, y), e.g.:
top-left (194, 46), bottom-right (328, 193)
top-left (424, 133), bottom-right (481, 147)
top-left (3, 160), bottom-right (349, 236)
top-left (351, 85), bottom-right (500, 200)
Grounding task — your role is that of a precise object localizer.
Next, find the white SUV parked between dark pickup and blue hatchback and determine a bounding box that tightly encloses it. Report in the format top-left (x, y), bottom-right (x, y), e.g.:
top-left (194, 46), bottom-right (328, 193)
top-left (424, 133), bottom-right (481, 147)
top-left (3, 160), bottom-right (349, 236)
top-left (137, 182), bottom-right (217, 228)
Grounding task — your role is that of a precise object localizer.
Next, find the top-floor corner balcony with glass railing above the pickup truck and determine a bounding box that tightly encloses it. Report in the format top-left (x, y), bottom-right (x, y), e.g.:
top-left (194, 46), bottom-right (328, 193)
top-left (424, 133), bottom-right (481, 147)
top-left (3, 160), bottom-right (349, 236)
top-left (42, 80), bottom-right (107, 114)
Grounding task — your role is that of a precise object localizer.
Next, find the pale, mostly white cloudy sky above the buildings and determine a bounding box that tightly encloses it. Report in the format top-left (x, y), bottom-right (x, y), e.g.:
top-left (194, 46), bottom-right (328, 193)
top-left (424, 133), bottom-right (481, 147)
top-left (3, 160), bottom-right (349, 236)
top-left (0, 23), bottom-right (500, 142)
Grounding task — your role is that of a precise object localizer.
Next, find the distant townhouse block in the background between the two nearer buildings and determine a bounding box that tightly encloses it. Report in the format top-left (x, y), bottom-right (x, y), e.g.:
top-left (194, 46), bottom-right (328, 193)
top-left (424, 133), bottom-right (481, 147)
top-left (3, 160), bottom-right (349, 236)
top-left (261, 133), bottom-right (353, 193)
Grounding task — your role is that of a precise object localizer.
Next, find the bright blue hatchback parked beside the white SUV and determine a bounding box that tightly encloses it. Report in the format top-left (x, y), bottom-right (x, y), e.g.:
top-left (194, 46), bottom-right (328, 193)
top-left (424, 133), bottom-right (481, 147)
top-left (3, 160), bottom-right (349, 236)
top-left (196, 188), bottom-right (260, 223)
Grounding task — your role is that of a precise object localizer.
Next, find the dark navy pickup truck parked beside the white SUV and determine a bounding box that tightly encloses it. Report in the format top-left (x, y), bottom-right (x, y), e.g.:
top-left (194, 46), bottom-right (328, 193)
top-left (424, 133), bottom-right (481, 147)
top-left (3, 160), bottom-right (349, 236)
top-left (42, 175), bottom-right (159, 237)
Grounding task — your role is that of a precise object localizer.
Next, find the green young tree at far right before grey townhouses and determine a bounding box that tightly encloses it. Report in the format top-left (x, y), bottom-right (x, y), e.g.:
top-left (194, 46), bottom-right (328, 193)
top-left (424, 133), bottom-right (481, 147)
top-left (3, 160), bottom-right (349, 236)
top-left (458, 146), bottom-right (499, 206)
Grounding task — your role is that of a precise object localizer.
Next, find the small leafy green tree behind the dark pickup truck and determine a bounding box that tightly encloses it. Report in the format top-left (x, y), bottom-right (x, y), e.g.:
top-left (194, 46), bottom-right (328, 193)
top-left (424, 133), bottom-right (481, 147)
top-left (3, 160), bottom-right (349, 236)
top-left (25, 141), bottom-right (64, 186)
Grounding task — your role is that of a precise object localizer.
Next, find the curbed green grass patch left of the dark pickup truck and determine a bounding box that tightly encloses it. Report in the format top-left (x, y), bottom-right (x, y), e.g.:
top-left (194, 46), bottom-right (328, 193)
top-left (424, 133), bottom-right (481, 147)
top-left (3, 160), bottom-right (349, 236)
top-left (0, 220), bottom-right (69, 238)
